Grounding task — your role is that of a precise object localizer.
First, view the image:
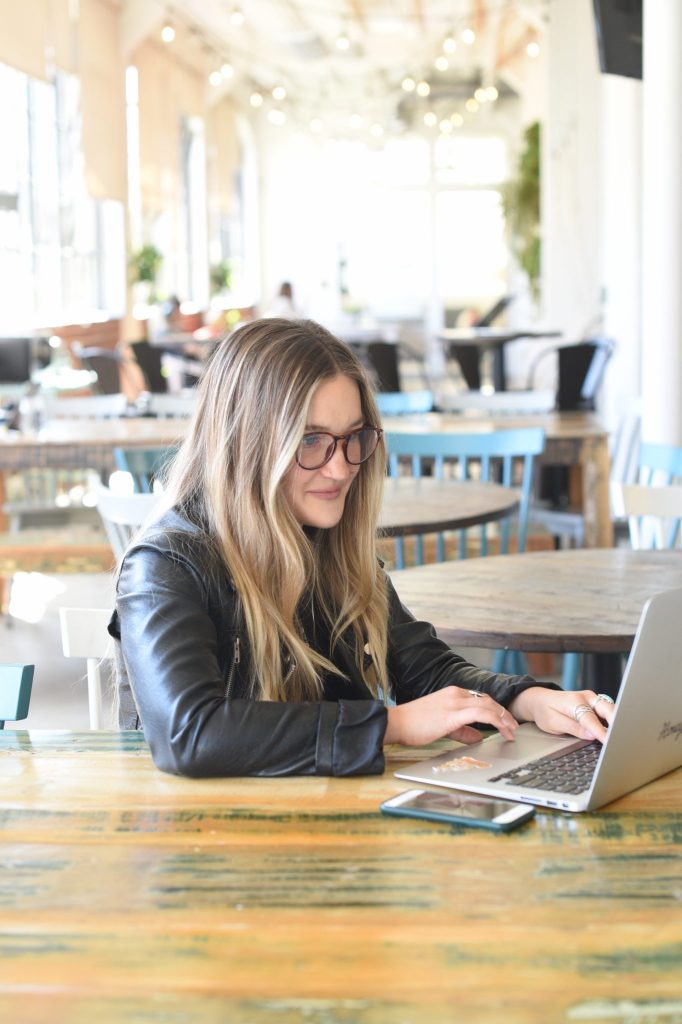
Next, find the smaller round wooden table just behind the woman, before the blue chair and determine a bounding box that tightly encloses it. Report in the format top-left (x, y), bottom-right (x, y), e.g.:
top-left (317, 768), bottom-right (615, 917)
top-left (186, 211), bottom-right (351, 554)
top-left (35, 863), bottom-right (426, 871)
top-left (380, 476), bottom-right (519, 537)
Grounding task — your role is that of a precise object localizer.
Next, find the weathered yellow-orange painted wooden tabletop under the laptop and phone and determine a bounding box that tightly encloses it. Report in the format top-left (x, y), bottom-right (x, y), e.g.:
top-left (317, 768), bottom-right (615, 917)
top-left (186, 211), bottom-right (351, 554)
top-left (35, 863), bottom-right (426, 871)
top-left (0, 729), bottom-right (682, 1024)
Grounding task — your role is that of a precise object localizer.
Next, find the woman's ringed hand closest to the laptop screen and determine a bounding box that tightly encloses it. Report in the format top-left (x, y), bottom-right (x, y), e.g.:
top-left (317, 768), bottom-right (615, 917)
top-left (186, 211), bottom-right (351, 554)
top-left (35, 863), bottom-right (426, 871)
top-left (509, 686), bottom-right (614, 743)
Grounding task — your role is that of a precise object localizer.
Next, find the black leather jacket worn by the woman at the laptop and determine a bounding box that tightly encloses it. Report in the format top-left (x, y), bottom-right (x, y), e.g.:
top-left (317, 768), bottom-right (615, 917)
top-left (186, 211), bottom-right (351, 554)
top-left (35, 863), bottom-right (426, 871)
top-left (110, 511), bottom-right (538, 777)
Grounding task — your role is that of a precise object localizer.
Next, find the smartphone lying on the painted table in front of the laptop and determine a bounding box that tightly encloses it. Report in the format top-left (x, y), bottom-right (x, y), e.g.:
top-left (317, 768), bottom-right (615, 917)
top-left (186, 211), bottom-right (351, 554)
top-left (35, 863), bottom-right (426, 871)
top-left (380, 790), bottom-right (536, 831)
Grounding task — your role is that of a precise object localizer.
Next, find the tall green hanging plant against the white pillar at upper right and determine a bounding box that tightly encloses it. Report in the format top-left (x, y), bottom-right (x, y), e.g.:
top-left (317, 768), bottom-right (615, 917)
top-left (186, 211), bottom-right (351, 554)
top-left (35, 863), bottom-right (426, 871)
top-left (502, 121), bottom-right (541, 300)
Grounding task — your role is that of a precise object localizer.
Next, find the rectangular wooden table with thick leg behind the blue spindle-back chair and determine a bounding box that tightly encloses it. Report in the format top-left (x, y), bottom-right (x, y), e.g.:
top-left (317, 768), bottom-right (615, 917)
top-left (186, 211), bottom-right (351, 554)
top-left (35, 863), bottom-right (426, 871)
top-left (382, 411), bottom-right (613, 548)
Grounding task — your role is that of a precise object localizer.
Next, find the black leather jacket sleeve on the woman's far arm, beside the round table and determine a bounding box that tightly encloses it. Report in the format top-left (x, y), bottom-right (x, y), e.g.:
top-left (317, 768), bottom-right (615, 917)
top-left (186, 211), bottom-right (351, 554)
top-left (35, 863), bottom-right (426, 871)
top-left (386, 578), bottom-right (560, 708)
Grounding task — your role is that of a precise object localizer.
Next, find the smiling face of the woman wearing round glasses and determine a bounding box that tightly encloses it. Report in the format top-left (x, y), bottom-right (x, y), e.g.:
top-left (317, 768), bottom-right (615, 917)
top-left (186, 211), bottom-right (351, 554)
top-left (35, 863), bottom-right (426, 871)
top-left (283, 376), bottom-right (365, 529)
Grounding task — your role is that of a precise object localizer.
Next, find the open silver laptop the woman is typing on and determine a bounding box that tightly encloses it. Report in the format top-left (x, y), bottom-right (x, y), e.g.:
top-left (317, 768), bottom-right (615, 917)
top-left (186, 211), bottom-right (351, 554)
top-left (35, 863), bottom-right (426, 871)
top-left (395, 589), bottom-right (682, 811)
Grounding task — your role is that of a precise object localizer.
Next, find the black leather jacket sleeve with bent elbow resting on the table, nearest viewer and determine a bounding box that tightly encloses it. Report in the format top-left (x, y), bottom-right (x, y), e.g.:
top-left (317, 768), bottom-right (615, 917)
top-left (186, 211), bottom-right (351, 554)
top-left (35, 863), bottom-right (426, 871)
top-left (116, 545), bottom-right (386, 777)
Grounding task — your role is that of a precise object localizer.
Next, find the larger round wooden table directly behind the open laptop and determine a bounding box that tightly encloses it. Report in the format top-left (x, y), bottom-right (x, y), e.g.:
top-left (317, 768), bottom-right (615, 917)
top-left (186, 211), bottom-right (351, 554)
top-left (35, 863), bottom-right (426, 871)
top-left (391, 548), bottom-right (682, 653)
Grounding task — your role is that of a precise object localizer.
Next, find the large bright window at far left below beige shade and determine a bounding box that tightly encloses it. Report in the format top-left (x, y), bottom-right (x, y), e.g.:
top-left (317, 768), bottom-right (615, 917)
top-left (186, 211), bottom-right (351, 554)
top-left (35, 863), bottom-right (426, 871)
top-left (0, 58), bottom-right (125, 330)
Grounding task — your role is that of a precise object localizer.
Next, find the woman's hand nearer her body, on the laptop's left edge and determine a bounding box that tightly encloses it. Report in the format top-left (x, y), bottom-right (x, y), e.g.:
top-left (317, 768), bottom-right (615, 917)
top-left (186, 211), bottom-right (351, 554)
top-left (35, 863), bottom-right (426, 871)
top-left (384, 686), bottom-right (518, 746)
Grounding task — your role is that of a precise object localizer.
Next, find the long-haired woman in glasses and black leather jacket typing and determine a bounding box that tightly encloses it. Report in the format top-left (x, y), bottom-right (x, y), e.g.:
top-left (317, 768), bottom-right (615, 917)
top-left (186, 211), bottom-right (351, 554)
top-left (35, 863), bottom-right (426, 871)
top-left (110, 318), bottom-right (611, 776)
